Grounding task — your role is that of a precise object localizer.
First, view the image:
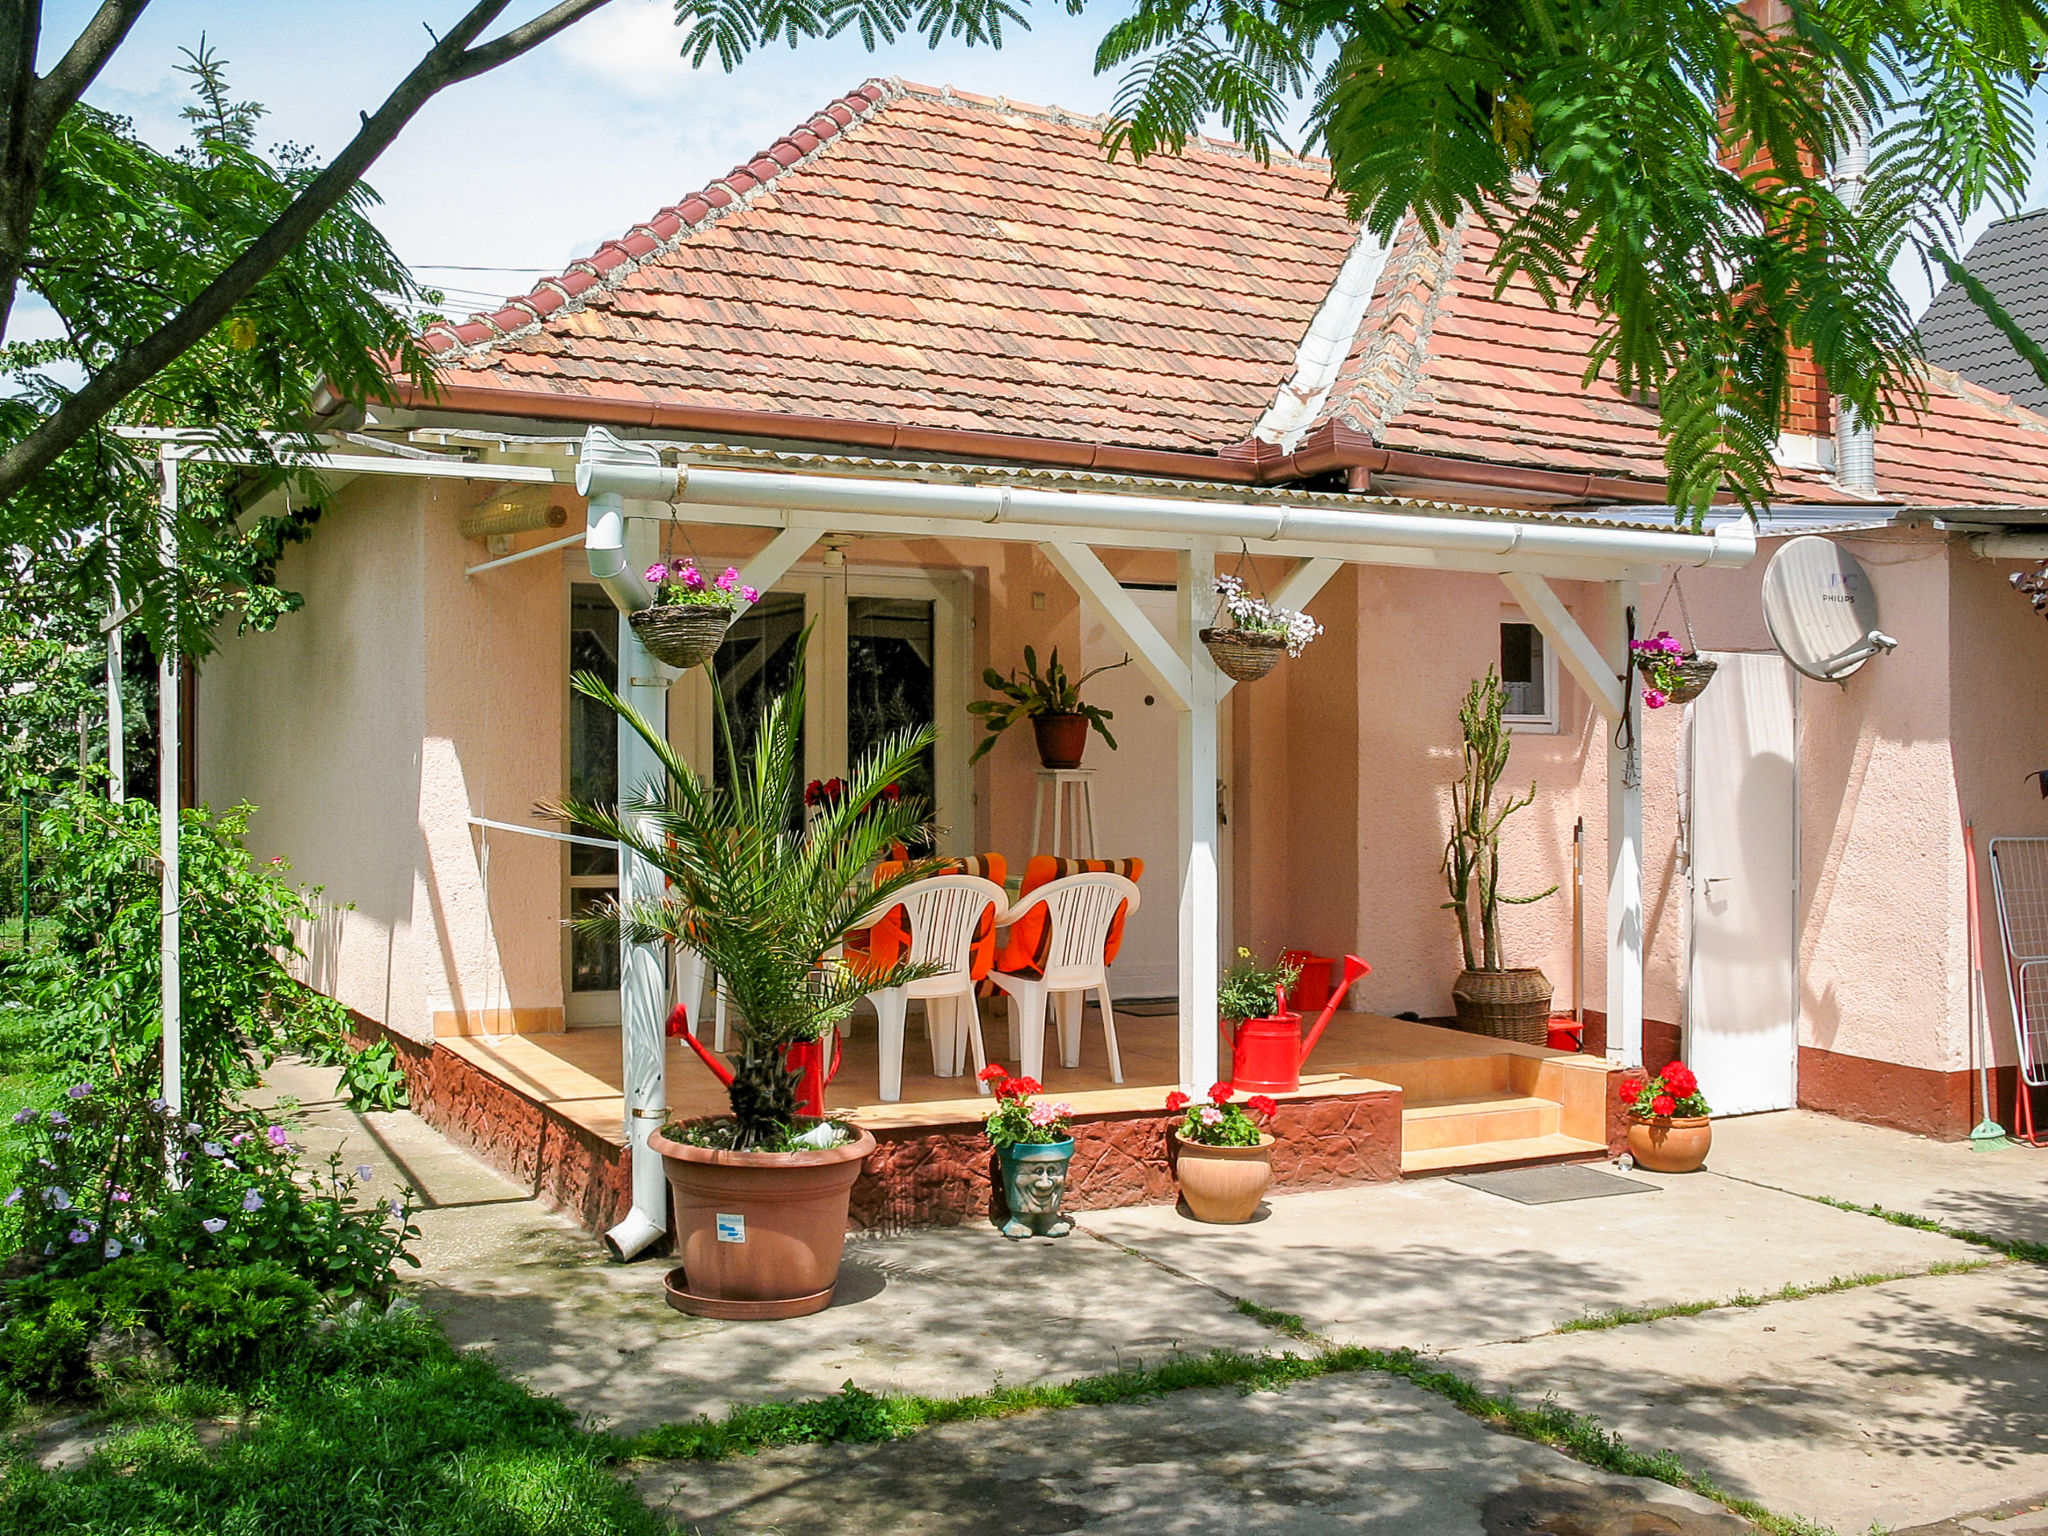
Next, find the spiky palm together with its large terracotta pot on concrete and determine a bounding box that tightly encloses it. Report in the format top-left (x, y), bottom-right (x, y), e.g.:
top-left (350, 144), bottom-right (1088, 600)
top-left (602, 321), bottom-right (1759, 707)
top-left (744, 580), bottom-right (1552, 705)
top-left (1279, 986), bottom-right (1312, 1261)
top-left (549, 641), bottom-right (932, 1319)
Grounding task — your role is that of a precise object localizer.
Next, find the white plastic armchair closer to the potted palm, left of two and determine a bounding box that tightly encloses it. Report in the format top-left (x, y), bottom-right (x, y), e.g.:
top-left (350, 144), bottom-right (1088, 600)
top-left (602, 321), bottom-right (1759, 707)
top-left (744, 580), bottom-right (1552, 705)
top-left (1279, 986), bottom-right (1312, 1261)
top-left (851, 874), bottom-right (1008, 1104)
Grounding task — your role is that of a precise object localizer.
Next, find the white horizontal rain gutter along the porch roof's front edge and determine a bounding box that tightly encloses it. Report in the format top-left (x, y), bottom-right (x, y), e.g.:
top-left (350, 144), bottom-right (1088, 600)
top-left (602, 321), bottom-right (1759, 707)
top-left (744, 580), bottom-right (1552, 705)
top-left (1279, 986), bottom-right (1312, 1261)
top-left (575, 428), bottom-right (1757, 580)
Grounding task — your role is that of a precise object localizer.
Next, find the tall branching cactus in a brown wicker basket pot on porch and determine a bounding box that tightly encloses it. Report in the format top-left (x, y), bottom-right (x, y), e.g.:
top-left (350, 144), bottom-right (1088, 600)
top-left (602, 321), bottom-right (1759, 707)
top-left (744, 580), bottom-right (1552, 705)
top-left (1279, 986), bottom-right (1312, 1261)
top-left (1444, 668), bottom-right (1556, 1044)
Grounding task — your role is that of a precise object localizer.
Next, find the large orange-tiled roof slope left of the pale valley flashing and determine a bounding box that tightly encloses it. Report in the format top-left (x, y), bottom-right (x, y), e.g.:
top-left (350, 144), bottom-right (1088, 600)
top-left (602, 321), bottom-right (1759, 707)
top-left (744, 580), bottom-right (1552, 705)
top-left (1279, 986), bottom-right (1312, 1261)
top-left (426, 82), bottom-right (1352, 451)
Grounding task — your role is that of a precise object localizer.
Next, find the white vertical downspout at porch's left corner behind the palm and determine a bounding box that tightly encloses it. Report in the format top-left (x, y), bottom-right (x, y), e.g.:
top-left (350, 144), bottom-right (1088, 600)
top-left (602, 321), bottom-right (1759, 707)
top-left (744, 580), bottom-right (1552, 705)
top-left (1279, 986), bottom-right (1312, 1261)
top-left (575, 442), bottom-right (670, 1260)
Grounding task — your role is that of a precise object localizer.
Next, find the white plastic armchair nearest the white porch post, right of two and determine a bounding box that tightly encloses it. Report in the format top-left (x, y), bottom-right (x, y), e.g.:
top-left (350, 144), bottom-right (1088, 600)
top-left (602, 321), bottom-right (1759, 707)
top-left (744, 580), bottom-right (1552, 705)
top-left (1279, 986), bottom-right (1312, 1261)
top-left (989, 872), bottom-right (1139, 1083)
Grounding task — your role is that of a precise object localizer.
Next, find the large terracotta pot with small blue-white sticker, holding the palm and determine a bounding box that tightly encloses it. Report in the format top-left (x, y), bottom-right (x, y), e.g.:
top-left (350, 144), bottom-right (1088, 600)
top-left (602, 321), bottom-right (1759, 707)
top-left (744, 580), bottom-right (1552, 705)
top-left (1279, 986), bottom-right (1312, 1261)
top-left (647, 1130), bottom-right (874, 1319)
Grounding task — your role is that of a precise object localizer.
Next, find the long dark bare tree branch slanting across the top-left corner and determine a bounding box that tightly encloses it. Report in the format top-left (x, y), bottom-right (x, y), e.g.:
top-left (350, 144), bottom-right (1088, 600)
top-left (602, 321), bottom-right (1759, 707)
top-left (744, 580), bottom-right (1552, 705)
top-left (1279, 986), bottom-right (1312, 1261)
top-left (0, 0), bottom-right (608, 512)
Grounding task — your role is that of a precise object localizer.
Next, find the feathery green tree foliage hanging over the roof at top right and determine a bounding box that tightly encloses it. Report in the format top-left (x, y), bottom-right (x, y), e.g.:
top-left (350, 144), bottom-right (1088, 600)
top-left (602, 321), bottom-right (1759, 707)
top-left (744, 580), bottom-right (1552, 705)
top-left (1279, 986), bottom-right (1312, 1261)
top-left (1096, 0), bottom-right (2048, 518)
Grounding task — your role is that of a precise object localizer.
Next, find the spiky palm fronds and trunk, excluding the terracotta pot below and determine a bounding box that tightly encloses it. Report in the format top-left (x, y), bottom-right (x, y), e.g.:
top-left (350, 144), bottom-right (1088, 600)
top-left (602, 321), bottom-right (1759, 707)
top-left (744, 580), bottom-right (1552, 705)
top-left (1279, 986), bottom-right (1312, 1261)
top-left (543, 637), bottom-right (932, 1149)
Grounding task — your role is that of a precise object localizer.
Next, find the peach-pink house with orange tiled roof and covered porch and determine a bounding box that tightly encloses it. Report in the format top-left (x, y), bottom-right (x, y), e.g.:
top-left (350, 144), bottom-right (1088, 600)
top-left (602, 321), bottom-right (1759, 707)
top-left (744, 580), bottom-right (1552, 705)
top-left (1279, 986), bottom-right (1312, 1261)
top-left (184, 80), bottom-right (2048, 1251)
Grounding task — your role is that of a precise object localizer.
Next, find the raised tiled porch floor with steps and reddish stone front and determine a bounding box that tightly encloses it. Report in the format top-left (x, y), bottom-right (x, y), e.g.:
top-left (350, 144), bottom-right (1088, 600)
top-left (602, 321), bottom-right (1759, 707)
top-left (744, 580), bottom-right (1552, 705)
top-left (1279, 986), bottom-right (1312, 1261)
top-left (436, 1012), bottom-right (1616, 1223)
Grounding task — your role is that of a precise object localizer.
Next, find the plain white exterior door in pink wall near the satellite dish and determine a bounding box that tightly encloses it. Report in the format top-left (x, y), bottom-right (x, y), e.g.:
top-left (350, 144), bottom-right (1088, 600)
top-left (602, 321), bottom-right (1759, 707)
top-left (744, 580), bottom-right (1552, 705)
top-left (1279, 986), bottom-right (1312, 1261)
top-left (1686, 651), bottom-right (1798, 1114)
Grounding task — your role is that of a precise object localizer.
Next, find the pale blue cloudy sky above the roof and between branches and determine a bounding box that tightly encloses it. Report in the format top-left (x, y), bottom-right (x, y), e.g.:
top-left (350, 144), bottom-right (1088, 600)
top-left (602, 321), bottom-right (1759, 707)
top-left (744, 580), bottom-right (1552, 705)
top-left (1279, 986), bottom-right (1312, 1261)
top-left (28, 0), bottom-right (2048, 336)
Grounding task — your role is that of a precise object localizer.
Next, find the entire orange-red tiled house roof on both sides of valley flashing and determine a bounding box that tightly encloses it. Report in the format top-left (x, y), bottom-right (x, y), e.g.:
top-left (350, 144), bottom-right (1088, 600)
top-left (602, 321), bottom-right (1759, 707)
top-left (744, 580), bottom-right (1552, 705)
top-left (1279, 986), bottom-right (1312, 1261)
top-left (407, 80), bottom-right (2048, 506)
